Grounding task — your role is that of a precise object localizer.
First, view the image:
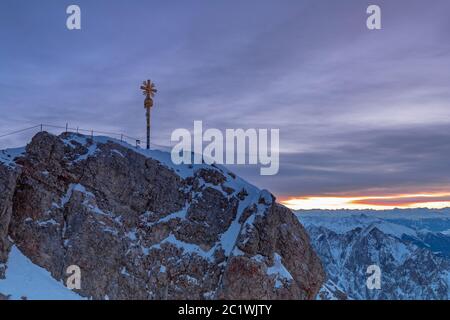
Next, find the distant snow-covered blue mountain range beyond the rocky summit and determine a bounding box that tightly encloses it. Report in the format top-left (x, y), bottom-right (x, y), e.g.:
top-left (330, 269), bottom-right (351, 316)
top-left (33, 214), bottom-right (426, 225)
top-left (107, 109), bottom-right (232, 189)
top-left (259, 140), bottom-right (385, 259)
top-left (296, 209), bottom-right (450, 300)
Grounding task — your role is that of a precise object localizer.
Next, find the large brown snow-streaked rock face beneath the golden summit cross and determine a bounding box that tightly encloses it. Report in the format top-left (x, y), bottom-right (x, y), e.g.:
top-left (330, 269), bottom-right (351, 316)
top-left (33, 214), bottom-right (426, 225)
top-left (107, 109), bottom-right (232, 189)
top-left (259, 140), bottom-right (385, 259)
top-left (0, 133), bottom-right (324, 299)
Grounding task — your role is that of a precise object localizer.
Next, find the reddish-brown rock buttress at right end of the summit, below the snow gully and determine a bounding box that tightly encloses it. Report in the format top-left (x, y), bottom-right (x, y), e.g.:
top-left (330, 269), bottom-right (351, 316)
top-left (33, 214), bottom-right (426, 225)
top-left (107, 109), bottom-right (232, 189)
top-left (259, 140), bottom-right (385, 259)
top-left (220, 203), bottom-right (323, 299)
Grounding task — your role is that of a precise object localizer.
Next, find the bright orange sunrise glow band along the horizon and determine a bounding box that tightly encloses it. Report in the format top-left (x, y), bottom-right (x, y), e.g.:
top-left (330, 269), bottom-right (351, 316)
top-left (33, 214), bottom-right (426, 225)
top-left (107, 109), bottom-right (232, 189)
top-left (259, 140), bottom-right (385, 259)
top-left (281, 193), bottom-right (450, 210)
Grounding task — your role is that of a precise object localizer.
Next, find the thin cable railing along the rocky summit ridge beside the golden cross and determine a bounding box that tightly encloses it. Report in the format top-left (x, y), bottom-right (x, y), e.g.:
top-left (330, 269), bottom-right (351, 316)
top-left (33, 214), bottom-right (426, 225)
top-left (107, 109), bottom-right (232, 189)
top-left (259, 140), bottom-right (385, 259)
top-left (0, 123), bottom-right (171, 149)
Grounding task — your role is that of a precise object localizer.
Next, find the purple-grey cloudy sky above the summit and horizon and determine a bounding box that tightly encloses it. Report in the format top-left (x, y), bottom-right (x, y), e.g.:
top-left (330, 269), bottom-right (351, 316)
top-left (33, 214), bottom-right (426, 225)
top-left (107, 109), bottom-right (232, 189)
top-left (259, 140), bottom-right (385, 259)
top-left (0, 0), bottom-right (450, 208)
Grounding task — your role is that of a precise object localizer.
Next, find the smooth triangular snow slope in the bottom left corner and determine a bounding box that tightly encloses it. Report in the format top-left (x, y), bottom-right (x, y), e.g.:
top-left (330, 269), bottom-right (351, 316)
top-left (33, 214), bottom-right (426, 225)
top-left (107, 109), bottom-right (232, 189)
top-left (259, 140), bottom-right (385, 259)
top-left (0, 246), bottom-right (84, 300)
